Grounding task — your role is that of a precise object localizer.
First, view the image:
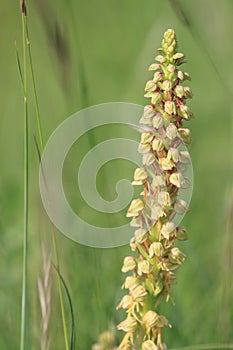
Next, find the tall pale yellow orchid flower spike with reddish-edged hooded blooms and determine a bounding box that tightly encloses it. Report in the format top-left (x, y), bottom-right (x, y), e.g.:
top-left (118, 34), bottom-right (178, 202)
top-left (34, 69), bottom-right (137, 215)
top-left (117, 29), bottom-right (192, 350)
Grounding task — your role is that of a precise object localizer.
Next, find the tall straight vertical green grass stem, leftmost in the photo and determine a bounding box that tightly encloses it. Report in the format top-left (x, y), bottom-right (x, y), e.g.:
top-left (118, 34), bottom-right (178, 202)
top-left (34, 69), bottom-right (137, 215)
top-left (20, 14), bottom-right (28, 350)
